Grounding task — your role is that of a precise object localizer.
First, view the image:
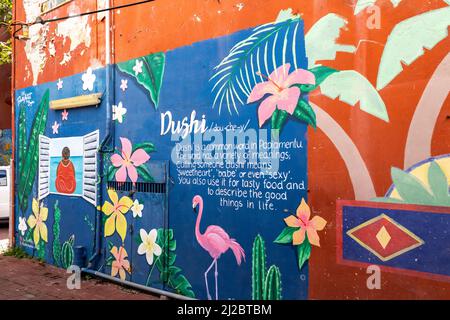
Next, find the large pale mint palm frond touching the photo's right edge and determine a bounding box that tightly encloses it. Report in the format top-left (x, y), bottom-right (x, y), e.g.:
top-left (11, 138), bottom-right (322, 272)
top-left (377, 7), bottom-right (450, 90)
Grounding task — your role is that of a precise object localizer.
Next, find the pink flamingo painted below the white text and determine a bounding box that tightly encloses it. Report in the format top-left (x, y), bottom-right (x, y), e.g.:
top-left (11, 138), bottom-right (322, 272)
top-left (192, 195), bottom-right (245, 300)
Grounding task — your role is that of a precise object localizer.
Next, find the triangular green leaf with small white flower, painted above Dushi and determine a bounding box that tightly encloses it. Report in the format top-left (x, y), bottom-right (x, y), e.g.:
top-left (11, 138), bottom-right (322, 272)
top-left (117, 52), bottom-right (166, 109)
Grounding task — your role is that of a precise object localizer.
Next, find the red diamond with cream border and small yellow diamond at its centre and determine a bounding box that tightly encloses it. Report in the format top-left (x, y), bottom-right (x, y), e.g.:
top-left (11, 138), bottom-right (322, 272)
top-left (347, 214), bottom-right (425, 261)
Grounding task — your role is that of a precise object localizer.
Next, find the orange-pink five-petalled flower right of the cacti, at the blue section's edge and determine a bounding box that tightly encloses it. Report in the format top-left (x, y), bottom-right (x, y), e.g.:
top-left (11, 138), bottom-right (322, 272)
top-left (284, 199), bottom-right (327, 247)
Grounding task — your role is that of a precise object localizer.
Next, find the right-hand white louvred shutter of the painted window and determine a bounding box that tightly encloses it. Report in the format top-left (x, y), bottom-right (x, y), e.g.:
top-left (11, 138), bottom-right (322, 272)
top-left (83, 130), bottom-right (100, 206)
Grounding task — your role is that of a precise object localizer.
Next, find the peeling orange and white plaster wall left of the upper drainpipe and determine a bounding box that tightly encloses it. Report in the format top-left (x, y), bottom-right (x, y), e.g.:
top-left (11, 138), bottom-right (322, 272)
top-left (15, 0), bottom-right (100, 88)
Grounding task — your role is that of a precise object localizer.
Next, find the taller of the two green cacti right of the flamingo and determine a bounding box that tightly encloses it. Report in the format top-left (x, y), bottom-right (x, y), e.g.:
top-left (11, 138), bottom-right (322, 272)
top-left (252, 234), bottom-right (266, 300)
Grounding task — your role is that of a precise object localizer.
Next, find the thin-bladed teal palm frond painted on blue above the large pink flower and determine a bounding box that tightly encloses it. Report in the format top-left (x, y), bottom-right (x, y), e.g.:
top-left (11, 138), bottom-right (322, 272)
top-left (210, 18), bottom-right (304, 114)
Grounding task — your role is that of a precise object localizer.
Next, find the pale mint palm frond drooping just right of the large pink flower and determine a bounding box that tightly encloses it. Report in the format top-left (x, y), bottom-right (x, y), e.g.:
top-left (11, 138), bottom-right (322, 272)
top-left (320, 70), bottom-right (389, 122)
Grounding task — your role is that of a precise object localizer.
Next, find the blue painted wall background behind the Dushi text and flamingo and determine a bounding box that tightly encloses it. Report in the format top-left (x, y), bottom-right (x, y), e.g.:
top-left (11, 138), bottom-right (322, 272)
top-left (16, 22), bottom-right (308, 299)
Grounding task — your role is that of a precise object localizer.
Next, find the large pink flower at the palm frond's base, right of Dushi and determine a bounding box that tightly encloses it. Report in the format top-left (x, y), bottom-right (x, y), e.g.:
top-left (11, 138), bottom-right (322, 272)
top-left (247, 63), bottom-right (316, 127)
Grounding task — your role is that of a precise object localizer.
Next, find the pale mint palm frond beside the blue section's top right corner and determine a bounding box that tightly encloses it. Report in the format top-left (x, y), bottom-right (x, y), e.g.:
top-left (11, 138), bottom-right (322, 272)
top-left (305, 13), bottom-right (356, 68)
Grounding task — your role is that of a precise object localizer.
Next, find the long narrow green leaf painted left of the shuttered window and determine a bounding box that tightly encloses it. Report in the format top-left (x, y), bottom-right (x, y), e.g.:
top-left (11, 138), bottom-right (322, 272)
top-left (18, 89), bottom-right (50, 212)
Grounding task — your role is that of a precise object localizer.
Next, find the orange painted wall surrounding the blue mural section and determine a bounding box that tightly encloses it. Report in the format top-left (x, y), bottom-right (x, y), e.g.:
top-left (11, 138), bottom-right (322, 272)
top-left (15, 0), bottom-right (450, 299)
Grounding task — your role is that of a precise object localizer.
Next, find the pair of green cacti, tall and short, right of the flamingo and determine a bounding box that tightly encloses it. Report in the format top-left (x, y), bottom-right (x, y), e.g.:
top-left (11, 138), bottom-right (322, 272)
top-left (252, 234), bottom-right (282, 300)
